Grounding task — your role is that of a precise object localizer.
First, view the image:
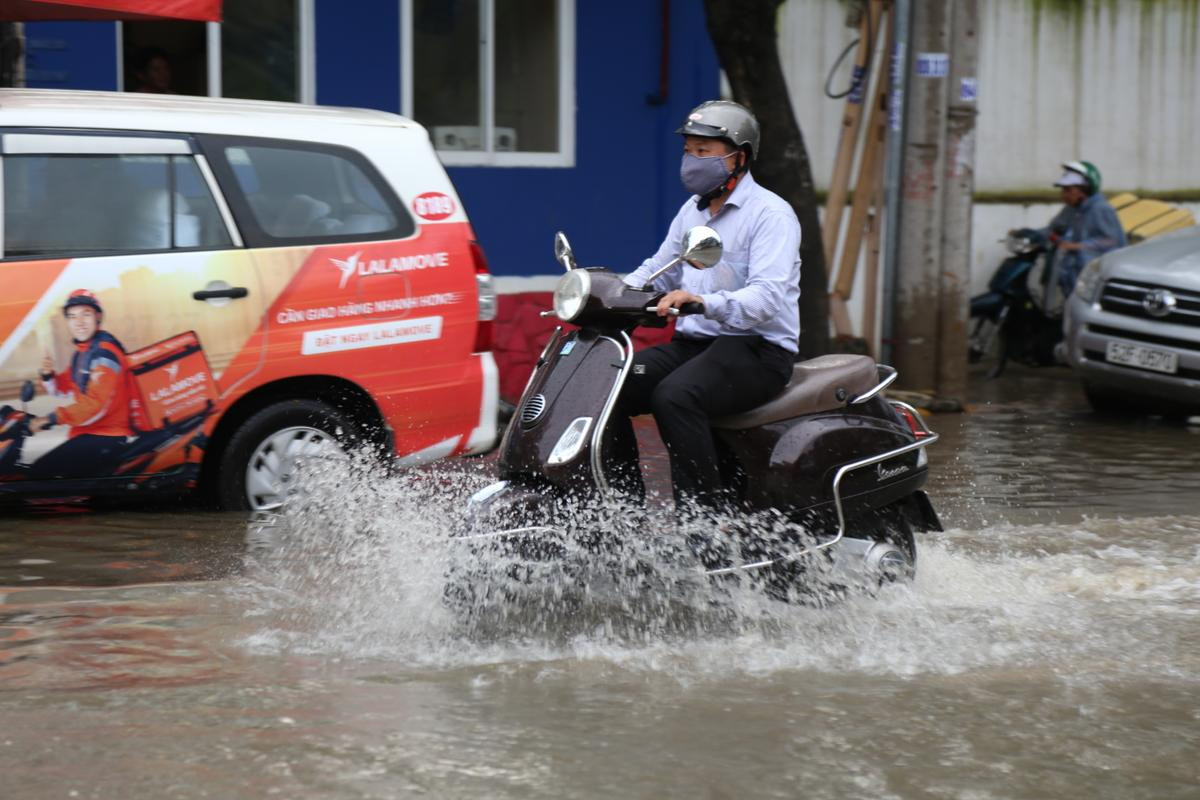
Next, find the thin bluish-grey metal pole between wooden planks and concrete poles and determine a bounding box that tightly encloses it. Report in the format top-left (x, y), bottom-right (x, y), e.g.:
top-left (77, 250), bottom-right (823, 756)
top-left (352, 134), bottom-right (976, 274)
top-left (878, 0), bottom-right (912, 362)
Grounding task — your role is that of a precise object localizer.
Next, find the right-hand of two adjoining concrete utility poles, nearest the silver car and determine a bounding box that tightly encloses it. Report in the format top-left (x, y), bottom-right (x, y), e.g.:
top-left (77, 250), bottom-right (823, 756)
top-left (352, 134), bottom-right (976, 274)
top-left (934, 0), bottom-right (979, 407)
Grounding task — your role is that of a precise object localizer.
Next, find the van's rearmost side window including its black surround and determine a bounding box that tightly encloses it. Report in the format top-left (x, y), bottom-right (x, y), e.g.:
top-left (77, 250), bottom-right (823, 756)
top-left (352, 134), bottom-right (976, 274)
top-left (205, 137), bottom-right (415, 246)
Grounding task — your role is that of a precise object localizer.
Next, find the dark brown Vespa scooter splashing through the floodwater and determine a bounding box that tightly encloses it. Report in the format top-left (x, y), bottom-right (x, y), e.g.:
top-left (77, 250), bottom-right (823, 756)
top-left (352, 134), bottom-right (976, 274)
top-left (448, 227), bottom-right (941, 607)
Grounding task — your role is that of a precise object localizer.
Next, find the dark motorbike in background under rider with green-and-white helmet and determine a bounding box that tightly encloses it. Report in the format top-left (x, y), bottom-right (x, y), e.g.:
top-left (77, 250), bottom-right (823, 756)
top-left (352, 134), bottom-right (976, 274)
top-left (967, 228), bottom-right (1063, 378)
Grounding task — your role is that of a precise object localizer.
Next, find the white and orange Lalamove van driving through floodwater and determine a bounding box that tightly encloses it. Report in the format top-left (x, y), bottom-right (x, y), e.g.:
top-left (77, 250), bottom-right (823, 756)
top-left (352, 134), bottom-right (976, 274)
top-left (0, 90), bottom-right (497, 510)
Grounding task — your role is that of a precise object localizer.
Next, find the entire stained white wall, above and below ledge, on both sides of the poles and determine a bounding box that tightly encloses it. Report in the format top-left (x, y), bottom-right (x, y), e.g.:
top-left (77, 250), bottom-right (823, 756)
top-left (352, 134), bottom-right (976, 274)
top-left (779, 0), bottom-right (1200, 340)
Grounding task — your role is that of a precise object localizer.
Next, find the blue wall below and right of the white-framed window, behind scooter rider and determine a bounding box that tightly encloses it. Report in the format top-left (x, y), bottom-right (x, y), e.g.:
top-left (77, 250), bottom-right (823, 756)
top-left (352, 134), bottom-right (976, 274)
top-left (450, 0), bottom-right (719, 275)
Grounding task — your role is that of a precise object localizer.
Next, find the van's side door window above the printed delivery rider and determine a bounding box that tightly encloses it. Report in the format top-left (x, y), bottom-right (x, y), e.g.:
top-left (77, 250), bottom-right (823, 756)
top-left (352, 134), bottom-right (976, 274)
top-left (4, 155), bottom-right (232, 258)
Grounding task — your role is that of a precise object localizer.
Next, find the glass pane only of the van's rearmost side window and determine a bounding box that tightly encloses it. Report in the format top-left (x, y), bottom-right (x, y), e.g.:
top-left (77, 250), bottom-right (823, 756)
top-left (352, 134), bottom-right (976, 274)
top-left (223, 144), bottom-right (414, 241)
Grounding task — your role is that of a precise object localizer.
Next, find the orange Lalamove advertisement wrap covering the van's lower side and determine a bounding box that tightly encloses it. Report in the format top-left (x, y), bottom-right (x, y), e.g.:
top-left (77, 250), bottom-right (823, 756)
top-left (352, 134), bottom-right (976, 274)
top-left (0, 221), bottom-right (485, 491)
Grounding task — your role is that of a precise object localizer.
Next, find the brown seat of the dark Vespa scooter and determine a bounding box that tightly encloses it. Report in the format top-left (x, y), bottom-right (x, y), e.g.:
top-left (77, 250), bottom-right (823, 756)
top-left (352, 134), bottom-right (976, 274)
top-left (710, 354), bottom-right (880, 431)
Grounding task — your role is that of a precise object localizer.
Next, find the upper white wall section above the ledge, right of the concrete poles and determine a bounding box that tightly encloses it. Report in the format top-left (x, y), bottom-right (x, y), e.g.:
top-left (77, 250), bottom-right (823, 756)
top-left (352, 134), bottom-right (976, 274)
top-left (976, 0), bottom-right (1200, 191)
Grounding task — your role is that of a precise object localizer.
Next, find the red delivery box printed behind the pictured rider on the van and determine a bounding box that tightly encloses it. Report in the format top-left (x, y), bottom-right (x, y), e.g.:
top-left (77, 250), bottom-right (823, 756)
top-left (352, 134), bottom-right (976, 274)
top-left (127, 331), bottom-right (217, 429)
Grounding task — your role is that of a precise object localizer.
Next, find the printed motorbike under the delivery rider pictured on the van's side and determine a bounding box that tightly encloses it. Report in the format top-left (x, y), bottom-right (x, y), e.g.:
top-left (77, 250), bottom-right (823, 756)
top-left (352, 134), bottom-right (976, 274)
top-left (0, 380), bottom-right (212, 494)
